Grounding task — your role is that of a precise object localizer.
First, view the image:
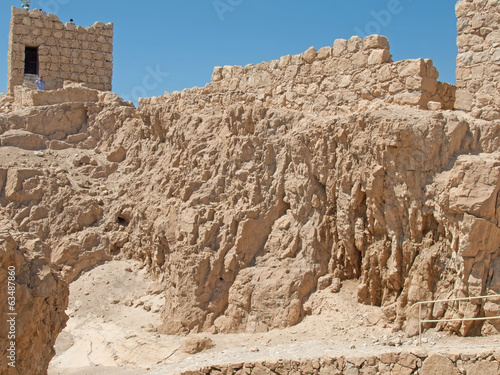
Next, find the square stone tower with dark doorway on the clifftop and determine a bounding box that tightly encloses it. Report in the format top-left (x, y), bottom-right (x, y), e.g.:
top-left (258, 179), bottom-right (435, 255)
top-left (8, 7), bottom-right (113, 93)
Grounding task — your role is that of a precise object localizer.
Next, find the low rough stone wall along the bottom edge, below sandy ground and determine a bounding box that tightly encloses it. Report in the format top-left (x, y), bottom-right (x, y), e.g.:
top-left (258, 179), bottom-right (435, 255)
top-left (173, 350), bottom-right (500, 375)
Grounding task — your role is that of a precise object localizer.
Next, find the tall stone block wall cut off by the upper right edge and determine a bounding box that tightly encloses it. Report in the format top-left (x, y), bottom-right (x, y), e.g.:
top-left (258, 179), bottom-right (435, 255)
top-left (455, 0), bottom-right (500, 120)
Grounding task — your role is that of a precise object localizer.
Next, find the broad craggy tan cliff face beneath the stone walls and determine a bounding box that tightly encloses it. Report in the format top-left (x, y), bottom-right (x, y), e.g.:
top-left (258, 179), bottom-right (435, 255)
top-left (0, 72), bottom-right (499, 340)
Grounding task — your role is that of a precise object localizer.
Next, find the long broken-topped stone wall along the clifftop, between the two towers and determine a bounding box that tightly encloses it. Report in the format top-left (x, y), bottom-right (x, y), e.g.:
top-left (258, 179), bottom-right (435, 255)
top-left (141, 35), bottom-right (455, 115)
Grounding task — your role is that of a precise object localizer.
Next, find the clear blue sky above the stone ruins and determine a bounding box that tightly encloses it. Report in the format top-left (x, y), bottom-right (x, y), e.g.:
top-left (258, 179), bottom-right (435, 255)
top-left (0, 0), bottom-right (457, 101)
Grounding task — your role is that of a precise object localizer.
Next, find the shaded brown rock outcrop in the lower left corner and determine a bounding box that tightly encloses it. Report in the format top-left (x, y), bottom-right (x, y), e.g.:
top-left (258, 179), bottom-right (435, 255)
top-left (0, 218), bottom-right (69, 375)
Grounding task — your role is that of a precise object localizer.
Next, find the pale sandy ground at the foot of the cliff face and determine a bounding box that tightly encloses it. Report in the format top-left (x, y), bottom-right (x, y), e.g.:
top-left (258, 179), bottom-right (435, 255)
top-left (48, 261), bottom-right (500, 375)
